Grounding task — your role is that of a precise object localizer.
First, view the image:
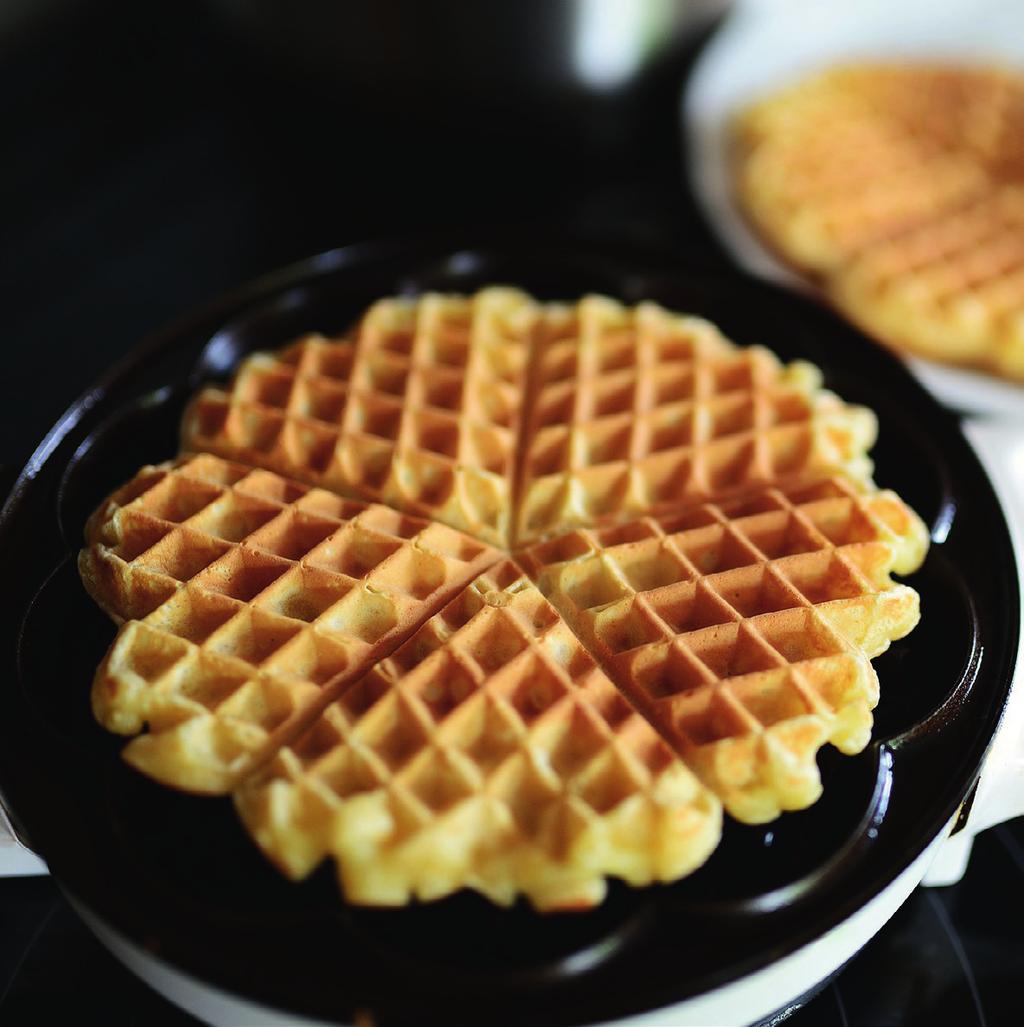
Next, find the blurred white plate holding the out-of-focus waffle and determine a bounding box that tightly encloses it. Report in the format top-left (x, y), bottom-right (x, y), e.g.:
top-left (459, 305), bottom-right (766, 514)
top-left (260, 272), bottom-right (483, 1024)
top-left (683, 0), bottom-right (1024, 418)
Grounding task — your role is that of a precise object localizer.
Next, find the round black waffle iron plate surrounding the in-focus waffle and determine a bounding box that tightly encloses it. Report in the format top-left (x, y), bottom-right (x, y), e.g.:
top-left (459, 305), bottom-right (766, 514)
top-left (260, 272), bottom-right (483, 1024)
top-left (0, 241), bottom-right (1020, 1027)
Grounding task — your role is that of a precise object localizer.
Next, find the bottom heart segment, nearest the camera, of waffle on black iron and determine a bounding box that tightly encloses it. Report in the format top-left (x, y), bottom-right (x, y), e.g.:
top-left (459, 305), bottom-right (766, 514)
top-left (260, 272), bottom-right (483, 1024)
top-left (236, 562), bottom-right (721, 910)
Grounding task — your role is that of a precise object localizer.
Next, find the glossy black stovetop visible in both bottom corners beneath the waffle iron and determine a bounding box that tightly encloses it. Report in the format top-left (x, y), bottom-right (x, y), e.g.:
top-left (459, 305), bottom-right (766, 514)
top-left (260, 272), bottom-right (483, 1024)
top-left (0, 820), bottom-right (1024, 1027)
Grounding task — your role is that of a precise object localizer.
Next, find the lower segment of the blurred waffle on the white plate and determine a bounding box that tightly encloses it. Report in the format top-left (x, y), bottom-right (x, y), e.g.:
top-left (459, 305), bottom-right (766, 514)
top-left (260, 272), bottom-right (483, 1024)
top-left (829, 186), bottom-right (1024, 381)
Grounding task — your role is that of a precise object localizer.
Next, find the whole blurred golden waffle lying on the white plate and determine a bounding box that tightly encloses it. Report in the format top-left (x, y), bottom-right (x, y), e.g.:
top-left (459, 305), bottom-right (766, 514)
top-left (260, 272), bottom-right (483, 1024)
top-left (736, 65), bottom-right (1024, 379)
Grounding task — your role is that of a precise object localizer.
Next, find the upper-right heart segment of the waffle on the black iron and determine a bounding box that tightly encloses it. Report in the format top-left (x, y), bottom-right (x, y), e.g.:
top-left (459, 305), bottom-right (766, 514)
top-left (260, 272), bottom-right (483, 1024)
top-left (517, 297), bottom-right (876, 543)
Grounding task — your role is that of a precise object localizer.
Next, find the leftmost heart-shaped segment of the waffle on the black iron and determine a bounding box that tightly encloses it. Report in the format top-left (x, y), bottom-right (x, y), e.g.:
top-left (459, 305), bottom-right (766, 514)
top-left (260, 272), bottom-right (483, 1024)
top-left (79, 456), bottom-right (497, 794)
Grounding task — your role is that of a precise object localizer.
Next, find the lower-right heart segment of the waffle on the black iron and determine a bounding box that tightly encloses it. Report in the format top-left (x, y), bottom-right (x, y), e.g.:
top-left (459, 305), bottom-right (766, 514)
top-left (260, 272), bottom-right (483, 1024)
top-left (524, 479), bottom-right (927, 823)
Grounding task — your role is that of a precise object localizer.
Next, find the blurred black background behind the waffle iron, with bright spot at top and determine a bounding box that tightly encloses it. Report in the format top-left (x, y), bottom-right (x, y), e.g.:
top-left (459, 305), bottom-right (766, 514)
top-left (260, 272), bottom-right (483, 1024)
top-left (0, 0), bottom-right (724, 473)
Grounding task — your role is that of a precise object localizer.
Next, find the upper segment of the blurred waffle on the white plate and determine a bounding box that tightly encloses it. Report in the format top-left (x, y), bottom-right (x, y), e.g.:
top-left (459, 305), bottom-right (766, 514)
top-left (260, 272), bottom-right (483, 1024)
top-left (736, 65), bottom-right (1024, 273)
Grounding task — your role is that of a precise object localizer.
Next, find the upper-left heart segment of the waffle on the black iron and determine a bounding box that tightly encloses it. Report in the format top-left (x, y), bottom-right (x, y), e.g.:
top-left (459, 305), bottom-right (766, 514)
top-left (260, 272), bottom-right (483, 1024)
top-left (183, 289), bottom-right (536, 545)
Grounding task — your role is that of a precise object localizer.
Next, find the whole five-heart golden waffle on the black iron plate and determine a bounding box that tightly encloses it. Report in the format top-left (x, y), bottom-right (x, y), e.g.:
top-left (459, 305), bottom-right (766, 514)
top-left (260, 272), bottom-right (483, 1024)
top-left (80, 289), bottom-right (926, 909)
